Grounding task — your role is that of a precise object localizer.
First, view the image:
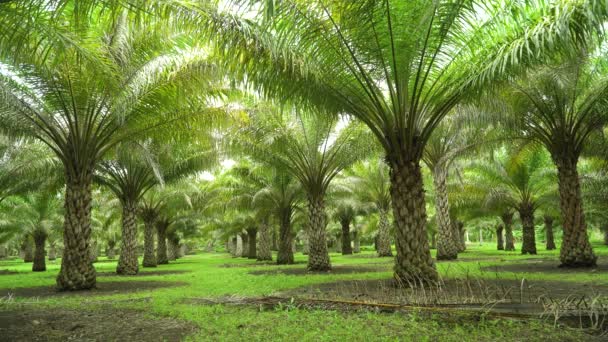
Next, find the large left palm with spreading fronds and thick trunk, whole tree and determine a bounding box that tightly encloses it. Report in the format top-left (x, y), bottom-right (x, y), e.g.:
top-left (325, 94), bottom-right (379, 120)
top-left (0, 7), bottom-right (215, 290)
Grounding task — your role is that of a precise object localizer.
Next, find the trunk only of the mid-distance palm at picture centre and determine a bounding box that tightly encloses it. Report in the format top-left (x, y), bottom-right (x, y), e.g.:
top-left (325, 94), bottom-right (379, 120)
top-left (308, 196), bottom-right (331, 271)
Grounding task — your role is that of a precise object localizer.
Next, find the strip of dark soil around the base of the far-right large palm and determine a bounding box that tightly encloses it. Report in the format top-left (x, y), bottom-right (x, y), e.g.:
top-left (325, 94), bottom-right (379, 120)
top-left (481, 258), bottom-right (608, 274)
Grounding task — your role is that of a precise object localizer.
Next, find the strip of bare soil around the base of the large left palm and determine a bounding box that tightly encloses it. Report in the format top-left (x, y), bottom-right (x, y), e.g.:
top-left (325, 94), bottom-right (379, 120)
top-left (0, 281), bottom-right (187, 298)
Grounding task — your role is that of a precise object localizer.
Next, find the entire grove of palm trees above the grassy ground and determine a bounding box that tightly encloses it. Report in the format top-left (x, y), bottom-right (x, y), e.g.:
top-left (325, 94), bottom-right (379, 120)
top-left (0, 0), bottom-right (608, 340)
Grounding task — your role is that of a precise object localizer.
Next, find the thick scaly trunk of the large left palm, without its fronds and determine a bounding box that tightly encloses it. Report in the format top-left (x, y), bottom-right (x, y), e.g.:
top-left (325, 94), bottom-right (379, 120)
top-left (57, 173), bottom-right (97, 290)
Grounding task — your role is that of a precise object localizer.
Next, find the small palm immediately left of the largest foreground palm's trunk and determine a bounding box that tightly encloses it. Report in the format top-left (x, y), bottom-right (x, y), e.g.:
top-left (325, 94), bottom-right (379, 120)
top-left (345, 159), bottom-right (393, 257)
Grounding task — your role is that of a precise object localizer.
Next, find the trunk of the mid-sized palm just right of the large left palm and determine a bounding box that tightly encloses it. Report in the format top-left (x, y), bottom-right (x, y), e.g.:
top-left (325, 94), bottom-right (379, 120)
top-left (116, 201), bottom-right (139, 275)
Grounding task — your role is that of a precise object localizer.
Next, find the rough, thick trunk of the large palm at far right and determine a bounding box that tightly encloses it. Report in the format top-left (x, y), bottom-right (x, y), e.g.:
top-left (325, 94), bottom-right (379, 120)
top-left (553, 156), bottom-right (597, 267)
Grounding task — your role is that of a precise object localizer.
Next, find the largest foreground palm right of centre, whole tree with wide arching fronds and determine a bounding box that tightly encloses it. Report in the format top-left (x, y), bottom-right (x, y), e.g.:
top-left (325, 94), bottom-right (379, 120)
top-left (211, 0), bottom-right (606, 284)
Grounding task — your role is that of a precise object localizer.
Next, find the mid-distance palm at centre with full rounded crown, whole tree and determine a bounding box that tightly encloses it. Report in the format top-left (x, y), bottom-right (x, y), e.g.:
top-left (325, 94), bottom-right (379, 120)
top-left (237, 109), bottom-right (368, 271)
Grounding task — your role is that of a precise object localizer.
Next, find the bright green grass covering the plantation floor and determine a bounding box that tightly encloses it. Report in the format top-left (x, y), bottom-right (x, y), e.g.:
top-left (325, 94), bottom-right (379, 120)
top-left (0, 243), bottom-right (608, 341)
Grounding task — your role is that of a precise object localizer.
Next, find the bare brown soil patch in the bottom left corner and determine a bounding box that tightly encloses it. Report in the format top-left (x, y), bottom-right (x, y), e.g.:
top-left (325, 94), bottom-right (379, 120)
top-left (0, 307), bottom-right (196, 341)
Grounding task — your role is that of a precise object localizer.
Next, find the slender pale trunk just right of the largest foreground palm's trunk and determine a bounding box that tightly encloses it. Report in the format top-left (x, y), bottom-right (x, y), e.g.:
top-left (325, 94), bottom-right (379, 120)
top-left (433, 165), bottom-right (458, 260)
